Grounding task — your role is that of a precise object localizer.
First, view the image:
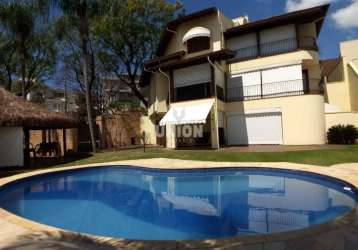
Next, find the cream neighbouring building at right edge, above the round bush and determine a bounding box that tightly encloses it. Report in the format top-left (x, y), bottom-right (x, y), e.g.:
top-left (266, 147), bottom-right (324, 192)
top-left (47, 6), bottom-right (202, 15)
top-left (321, 40), bottom-right (358, 129)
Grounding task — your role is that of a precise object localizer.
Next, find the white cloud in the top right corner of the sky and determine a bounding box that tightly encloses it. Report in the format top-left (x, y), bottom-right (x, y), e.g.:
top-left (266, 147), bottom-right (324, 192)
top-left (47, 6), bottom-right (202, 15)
top-left (332, 0), bottom-right (358, 29)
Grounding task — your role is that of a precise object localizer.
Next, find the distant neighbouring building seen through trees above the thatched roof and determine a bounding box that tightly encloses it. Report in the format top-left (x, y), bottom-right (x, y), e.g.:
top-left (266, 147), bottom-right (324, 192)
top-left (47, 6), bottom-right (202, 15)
top-left (27, 85), bottom-right (78, 112)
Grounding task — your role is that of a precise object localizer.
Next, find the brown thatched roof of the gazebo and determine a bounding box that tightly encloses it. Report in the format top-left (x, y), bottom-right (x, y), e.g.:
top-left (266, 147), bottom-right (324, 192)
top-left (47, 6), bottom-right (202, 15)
top-left (0, 87), bottom-right (78, 129)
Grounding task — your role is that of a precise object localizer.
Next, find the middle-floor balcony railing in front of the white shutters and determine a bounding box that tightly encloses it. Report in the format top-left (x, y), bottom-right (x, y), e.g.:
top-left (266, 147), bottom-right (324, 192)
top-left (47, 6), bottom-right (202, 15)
top-left (227, 79), bottom-right (308, 102)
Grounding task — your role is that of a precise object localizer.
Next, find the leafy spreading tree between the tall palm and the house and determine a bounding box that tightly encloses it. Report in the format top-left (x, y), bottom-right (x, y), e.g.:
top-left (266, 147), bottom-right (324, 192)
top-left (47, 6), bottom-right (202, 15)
top-left (95, 0), bottom-right (181, 106)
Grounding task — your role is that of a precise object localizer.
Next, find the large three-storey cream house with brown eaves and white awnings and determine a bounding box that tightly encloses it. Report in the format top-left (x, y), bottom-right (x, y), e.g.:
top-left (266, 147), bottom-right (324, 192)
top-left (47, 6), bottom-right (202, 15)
top-left (141, 5), bottom-right (329, 148)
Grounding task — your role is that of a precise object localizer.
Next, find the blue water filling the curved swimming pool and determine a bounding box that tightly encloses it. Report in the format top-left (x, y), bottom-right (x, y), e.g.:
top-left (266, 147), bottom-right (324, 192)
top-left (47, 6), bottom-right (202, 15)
top-left (0, 166), bottom-right (357, 240)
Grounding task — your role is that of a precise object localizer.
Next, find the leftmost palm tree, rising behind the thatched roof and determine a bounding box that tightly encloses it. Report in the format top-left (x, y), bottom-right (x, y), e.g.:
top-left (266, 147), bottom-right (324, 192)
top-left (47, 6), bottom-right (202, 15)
top-left (0, 0), bottom-right (45, 98)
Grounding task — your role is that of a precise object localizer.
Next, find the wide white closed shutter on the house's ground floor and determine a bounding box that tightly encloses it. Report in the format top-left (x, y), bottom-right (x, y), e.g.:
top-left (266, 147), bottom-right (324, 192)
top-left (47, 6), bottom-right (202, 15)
top-left (227, 112), bottom-right (282, 145)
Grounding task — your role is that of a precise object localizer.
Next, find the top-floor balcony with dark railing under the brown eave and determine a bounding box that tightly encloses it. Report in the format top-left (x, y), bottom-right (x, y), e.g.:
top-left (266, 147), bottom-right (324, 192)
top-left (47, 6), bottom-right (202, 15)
top-left (228, 36), bottom-right (318, 63)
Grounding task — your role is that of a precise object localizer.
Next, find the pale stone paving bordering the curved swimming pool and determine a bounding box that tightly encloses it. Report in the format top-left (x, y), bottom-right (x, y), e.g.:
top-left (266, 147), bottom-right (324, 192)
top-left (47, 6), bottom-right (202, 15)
top-left (0, 158), bottom-right (358, 249)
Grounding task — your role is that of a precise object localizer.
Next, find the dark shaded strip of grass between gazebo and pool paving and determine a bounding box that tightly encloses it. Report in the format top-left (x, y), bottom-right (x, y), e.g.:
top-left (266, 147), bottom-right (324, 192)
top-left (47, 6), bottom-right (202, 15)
top-left (0, 153), bottom-right (92, 178)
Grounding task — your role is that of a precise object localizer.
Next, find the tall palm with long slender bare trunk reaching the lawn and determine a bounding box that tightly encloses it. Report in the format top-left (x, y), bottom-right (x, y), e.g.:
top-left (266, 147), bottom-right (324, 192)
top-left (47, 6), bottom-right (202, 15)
top-left (52, 0), bottom-right (110, 152)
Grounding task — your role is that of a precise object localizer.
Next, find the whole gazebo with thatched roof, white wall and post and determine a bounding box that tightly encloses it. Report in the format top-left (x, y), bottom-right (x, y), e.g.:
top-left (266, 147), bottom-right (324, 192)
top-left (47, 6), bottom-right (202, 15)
top-left (0, 87), bottom-right (79, 166)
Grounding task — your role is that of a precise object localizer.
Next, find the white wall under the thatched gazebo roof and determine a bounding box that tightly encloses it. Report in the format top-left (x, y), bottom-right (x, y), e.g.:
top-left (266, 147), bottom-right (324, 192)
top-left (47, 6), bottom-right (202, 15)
top-left (0, 127), bottom-right (24, 167)
